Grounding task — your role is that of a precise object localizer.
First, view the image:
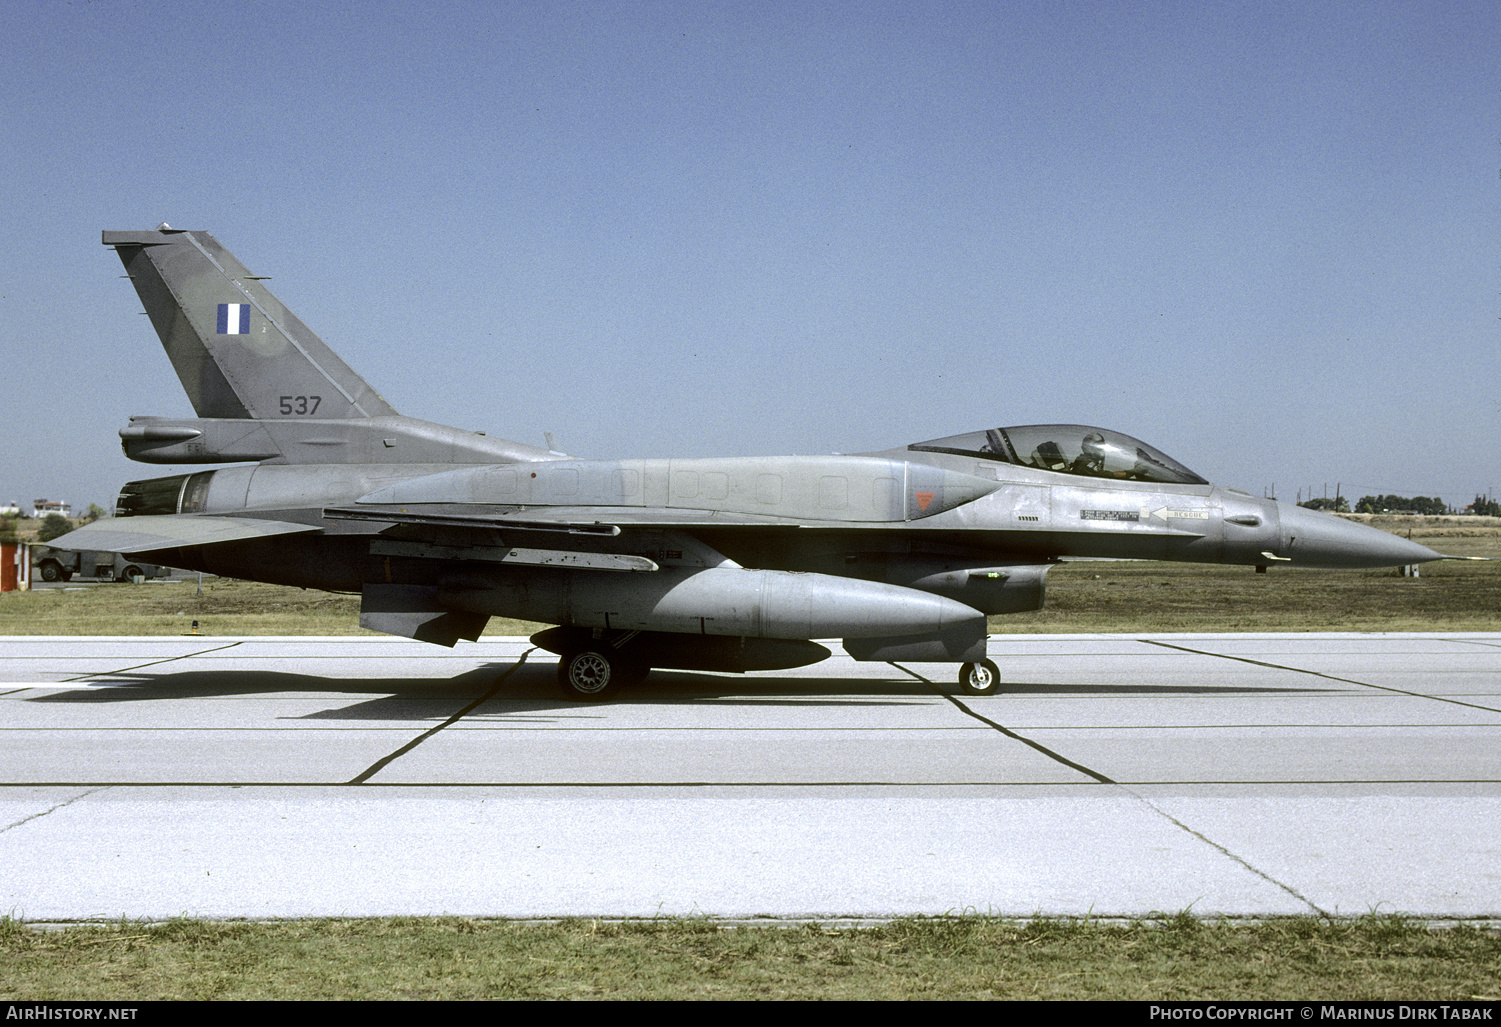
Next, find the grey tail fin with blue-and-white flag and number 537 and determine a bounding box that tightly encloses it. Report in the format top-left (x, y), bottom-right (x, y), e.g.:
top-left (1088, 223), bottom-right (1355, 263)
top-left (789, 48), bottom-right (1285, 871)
top-left (104, 224), bottom-right (396, 420)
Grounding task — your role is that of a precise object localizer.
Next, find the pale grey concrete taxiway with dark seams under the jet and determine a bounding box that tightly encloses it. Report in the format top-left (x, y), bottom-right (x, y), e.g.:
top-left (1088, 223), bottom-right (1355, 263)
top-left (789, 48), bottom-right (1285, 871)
top-left (0, 634), bottom-right (1501, 920)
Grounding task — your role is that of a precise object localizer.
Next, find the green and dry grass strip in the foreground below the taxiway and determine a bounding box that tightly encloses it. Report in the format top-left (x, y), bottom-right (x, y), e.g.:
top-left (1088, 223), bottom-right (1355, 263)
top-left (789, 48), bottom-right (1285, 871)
top-left (0, 913), bottom-right (1501, 1001)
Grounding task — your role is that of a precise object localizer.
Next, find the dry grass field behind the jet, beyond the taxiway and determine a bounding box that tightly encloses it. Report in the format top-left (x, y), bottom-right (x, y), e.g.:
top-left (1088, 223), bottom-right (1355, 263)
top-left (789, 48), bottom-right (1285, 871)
top-left (0, 517), bottom-right (1501, 637)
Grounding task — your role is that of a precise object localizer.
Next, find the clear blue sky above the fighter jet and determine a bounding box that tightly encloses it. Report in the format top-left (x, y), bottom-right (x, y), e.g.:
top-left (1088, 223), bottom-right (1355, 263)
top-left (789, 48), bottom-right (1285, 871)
top-left (0, 0), bottom-right (1501, 506)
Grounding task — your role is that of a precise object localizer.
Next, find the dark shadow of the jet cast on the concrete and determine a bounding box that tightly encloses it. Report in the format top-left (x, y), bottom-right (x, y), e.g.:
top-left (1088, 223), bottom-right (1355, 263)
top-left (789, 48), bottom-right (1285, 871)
top-left (29, 661), bottom-right (1340, 721)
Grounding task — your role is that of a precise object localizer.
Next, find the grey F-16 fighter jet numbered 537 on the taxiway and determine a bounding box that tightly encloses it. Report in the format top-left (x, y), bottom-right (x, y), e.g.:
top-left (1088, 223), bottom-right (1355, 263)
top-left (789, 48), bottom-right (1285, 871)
top-left (53, 224), bottom-right (1441, 700)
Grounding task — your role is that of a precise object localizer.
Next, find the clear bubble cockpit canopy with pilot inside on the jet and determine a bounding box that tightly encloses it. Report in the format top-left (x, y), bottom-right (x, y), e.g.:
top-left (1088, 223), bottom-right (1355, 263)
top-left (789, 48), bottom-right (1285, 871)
top-left (908, 425), bottom-right (1208, 485)
